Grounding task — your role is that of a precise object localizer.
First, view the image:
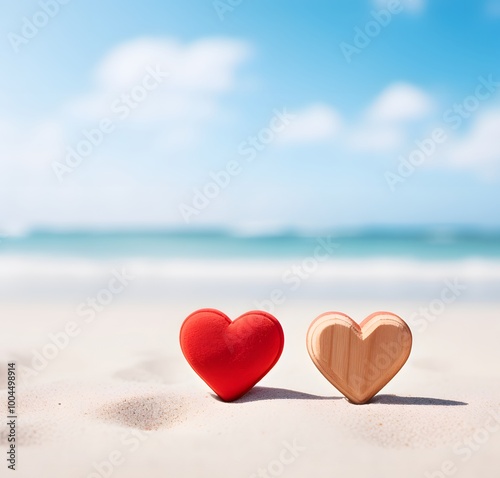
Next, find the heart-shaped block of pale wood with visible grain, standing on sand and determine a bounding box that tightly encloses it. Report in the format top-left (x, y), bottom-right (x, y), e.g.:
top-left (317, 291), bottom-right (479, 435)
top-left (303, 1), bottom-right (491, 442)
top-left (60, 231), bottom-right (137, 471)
top-left (307, 312), bottom-right (412, 403)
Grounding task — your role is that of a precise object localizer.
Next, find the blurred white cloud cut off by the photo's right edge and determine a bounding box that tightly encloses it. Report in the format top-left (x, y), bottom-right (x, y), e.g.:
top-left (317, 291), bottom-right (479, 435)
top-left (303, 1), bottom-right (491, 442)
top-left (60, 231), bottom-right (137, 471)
top-left (448, 109), bottom-right (500, 171)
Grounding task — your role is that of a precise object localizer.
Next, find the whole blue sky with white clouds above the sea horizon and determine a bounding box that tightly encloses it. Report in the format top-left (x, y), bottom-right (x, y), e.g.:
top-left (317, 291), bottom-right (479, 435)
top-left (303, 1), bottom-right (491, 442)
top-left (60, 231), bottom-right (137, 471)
top-left (0, 0), bottom-right (500, 232)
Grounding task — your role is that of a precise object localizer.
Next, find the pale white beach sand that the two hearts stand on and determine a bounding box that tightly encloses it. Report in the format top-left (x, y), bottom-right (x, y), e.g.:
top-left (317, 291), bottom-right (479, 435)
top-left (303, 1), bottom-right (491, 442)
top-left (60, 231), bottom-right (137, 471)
top-left (0, 300), bottom-right (500, 478)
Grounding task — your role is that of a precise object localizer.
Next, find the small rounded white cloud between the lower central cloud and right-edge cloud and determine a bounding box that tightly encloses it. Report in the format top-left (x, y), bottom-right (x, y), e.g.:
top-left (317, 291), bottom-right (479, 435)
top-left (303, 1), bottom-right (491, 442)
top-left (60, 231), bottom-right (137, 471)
top-left (366, 83), bottom-right (433, 122)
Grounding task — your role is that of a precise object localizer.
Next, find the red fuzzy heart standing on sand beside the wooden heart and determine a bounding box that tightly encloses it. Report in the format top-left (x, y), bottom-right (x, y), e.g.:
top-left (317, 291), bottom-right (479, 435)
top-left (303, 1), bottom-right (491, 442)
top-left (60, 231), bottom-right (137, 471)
top-left (180, 309), bottom-right (285, 402)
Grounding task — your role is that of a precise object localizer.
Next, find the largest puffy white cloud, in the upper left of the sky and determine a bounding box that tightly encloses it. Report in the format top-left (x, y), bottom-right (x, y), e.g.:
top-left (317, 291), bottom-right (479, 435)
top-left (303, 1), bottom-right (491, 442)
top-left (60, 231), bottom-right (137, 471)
top-left (70, 38), bottom-right (250, 121)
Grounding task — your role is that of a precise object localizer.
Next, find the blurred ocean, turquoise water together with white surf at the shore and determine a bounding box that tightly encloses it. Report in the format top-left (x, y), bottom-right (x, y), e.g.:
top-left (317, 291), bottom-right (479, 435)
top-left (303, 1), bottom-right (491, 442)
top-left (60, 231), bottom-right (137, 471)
top-left (0, 229), bottom-right (500, 303)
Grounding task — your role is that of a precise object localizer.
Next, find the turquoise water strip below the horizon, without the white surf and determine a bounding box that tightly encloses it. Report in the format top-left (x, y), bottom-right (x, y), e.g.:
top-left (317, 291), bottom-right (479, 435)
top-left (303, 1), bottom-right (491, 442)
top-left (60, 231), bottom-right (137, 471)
top-left (0, 230), bottom-right (500, 260)
